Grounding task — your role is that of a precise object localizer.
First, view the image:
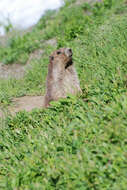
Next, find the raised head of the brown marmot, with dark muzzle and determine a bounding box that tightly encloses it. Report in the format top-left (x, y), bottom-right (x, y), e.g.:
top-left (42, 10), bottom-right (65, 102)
top-left (50, 48), bottom-right (73, 69)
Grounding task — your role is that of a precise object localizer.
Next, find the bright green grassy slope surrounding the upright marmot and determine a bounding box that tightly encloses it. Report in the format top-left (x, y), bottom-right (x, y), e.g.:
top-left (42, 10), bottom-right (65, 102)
top-left (0, 0), bottom-right (127, 190)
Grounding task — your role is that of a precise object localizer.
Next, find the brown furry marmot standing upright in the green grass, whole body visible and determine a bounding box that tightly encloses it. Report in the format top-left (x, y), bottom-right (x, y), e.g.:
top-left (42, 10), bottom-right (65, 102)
top-left (44, 48), bottom-right (81, 107)
